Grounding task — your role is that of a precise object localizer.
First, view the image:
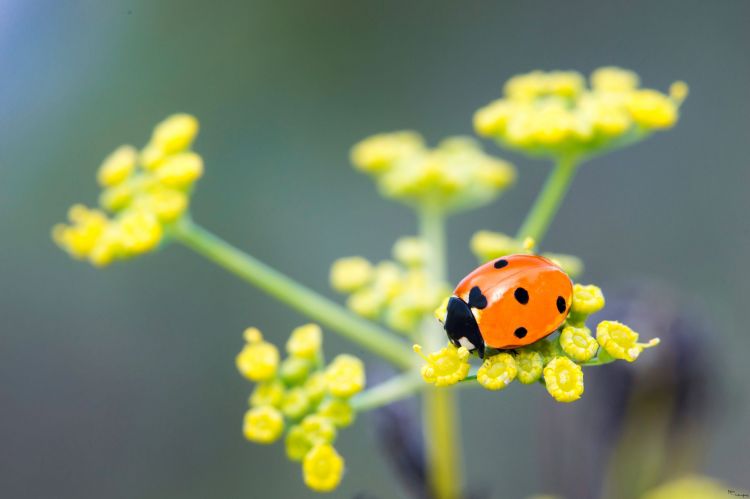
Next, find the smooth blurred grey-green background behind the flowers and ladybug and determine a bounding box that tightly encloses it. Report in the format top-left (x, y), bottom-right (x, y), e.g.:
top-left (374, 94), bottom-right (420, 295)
top-left (0, 0), bottom-right (750, 499)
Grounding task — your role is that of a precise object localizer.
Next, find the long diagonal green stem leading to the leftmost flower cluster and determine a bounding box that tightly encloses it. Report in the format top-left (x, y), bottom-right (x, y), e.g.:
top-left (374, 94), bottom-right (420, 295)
top-left (172, 218), bottom-right (414, 369)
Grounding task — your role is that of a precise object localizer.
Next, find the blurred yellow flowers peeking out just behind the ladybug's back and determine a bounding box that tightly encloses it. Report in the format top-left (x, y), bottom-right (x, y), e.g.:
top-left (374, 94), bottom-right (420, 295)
top-left (470, 230), bottom-right (583, 278)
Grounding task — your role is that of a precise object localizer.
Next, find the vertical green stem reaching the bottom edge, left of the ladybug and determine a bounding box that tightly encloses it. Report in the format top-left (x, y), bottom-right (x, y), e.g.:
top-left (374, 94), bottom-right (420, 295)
top-left (418, 206), bottom-right (463, 499)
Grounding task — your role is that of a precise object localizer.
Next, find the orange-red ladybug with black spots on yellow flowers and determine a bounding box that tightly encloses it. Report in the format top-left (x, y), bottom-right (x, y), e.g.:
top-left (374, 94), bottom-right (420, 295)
top-left (443, 255), bottom-right (573, 358)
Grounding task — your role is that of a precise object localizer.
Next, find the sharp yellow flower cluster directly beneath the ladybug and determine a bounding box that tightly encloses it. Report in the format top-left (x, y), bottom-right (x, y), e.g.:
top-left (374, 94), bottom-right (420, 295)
top-left (414, 284), bottom-right (659, 402)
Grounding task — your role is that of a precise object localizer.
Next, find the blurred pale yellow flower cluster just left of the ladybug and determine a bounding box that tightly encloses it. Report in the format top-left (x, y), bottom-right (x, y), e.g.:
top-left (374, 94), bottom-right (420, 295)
top-left (330, 237), bottom-right (449, 334)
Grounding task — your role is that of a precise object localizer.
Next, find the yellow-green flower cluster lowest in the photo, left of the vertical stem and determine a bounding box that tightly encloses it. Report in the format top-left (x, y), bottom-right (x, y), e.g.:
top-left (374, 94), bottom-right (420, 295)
top-left (236, 324), bottom-right (365, 492)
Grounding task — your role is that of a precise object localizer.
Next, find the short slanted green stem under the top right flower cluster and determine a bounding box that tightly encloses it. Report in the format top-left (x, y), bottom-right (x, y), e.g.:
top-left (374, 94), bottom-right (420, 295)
top-left (516, 156), bottom-right (580, 245)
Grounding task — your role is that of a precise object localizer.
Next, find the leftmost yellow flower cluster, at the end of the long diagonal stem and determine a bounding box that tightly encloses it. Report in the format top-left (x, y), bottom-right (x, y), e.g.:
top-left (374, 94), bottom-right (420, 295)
top-left (52, 114), bottom-right (203, 266)
